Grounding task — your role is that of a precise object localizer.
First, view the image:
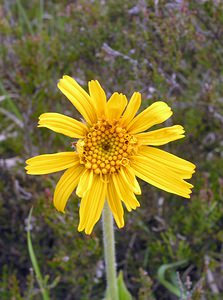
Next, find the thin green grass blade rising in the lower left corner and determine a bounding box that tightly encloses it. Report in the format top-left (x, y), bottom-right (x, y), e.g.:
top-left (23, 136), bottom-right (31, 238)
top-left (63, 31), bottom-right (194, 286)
top-left (27, 207), bottom-right (50, 300)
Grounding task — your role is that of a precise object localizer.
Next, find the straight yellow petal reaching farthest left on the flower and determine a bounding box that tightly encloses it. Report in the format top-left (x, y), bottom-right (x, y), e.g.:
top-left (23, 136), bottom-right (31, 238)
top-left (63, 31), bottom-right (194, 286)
top-left (25, 152), bottom-right (79, 175)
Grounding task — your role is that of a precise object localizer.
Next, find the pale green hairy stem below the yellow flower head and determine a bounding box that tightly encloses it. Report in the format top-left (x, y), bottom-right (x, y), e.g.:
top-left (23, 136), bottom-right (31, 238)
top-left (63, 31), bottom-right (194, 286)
top-left (102, 201), bottom-right (119, 300)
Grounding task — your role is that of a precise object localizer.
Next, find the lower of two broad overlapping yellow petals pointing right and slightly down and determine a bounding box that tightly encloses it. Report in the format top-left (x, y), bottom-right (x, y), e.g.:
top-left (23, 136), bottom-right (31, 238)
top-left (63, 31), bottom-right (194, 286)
top-left (131, 156), bottom-right (193, 198)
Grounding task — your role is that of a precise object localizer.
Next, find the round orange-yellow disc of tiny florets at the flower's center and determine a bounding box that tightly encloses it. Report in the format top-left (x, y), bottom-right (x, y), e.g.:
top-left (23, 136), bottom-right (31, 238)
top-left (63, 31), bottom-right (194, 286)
top-left (77, 119), bottom-right (137, 175)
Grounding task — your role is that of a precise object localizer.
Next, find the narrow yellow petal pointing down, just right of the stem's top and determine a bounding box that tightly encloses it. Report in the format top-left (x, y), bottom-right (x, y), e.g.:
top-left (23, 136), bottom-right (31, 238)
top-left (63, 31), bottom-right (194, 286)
top-left (108, 180), bottom-right (124, 228)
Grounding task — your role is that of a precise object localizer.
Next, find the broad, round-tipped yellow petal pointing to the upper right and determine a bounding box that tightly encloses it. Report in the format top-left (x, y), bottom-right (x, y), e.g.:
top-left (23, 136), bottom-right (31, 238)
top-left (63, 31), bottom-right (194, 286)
top-left (127, 101), bottom-right (173, 134)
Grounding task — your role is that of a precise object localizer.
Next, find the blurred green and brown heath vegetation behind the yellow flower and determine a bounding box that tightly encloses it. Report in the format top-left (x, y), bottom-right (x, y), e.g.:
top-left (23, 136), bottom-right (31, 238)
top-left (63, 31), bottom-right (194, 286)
top-left (0, 0), bottom-right (223, 300)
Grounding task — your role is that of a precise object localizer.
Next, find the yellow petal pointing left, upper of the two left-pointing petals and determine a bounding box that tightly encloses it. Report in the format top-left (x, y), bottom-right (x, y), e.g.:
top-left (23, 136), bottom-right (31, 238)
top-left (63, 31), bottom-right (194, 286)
top-left (38, 113), bottom-right (88, 138)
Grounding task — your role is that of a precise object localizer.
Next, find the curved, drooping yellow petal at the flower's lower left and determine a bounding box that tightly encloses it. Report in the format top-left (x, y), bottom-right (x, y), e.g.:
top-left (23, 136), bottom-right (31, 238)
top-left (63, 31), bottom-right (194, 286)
top-left (53, 165), bottom-right (84, 212)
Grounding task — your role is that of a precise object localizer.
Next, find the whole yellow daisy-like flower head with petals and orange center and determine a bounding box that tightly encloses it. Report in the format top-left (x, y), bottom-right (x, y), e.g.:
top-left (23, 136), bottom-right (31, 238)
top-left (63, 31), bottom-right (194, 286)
top-left (26, 76), bottom-right (195, 234)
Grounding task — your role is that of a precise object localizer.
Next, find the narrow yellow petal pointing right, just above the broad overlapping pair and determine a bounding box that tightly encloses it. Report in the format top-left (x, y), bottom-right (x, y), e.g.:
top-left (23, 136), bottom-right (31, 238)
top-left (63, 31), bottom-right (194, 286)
top-left (136, 125), bottom-right (184, 146)
